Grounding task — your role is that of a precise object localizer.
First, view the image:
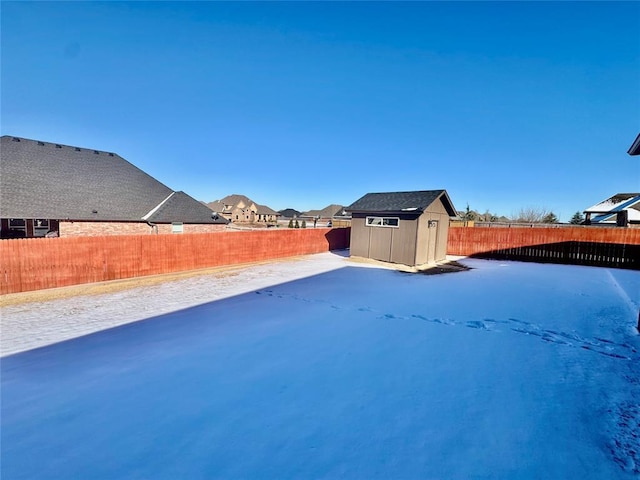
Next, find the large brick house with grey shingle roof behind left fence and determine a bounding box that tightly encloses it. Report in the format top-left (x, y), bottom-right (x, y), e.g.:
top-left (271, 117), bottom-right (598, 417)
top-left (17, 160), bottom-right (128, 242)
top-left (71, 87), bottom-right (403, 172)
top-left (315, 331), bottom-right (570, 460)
top-left (0, 136), bottom-right (227, 238)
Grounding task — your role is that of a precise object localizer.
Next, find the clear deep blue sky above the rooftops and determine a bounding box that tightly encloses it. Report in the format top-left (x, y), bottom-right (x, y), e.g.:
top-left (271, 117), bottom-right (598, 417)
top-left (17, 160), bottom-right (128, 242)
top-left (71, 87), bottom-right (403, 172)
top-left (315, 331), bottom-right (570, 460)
top-left (1, 1), bottom-right (640, 220)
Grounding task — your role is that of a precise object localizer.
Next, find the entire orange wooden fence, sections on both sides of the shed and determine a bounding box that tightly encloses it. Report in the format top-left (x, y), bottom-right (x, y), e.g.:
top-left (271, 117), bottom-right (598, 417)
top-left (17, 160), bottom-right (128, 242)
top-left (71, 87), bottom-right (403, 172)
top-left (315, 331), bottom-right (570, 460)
top-left (0, 227), bottom-right (640, 294)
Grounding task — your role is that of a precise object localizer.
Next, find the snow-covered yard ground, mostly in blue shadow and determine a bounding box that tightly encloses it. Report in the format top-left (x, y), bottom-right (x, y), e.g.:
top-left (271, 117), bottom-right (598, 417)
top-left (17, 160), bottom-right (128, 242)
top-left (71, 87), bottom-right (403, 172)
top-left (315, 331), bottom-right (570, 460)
top-left (1, 253), bottom-right (640, 480)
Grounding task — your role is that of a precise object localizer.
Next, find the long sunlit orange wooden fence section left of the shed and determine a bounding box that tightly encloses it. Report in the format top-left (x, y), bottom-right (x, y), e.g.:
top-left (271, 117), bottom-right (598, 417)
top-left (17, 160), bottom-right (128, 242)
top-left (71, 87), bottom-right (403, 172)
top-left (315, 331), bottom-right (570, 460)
top-left (0, 228), bottom-right (350, 294)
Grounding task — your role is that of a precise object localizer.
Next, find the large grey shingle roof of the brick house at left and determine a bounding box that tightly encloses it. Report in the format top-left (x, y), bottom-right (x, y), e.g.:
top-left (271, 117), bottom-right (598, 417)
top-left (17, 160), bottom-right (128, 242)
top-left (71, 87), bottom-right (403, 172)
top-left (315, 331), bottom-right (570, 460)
top-left (0, 136), bottom-right (225, 223)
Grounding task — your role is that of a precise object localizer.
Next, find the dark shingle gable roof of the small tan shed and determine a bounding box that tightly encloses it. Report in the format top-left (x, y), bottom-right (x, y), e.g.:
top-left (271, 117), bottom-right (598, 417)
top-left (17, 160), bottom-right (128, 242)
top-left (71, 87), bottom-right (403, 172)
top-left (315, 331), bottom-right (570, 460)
top-left (345, 190), bottom-right (456, 217)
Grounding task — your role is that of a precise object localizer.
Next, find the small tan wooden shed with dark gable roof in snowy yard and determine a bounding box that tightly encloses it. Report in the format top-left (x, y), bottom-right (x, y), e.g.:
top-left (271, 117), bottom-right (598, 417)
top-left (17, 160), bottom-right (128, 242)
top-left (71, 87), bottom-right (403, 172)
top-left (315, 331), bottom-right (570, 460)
top-left (345, 190), bottom-right (456, 266)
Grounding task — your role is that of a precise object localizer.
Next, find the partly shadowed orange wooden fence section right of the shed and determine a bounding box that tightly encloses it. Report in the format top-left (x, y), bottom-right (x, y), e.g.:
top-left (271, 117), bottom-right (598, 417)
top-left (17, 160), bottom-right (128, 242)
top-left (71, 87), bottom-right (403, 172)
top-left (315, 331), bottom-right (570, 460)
top-left (447, 227), bottom-right (640, 269)
